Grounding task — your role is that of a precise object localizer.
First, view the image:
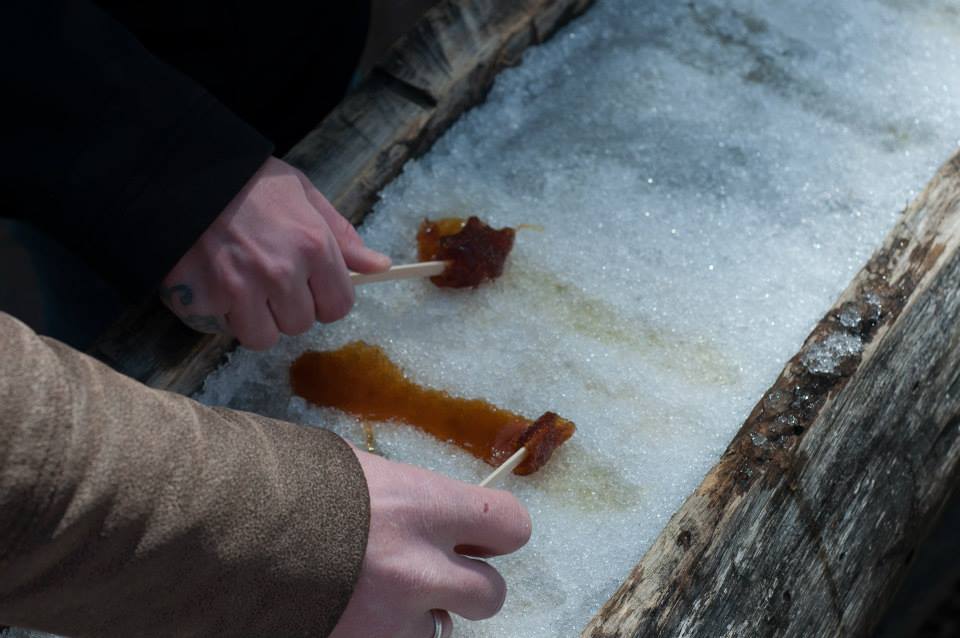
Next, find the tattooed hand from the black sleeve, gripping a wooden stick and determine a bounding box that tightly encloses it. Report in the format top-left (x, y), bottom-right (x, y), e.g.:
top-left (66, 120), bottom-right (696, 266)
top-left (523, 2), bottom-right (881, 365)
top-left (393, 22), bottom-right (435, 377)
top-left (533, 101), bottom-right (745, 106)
top-left (162, 157), bottom-right (390, 350)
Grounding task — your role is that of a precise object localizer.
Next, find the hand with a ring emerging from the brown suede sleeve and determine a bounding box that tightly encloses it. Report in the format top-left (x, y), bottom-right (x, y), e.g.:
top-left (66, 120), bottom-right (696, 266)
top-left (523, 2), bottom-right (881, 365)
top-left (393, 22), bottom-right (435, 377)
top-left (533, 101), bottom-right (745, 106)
top-left (330, 449), bottom-right (531, 638)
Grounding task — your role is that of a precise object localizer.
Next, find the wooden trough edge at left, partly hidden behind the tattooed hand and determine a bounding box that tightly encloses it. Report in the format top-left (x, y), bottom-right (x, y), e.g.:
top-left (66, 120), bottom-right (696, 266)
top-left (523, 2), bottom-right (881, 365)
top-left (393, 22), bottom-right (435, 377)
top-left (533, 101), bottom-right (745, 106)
top-left (89, 0), bottom-right (593, 394)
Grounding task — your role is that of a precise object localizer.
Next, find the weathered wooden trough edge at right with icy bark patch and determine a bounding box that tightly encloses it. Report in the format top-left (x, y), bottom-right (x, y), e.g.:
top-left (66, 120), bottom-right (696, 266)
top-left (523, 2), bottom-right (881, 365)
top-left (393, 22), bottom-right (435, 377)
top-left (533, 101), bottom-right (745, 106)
top-left (582, 153), bottom-right (960, 638)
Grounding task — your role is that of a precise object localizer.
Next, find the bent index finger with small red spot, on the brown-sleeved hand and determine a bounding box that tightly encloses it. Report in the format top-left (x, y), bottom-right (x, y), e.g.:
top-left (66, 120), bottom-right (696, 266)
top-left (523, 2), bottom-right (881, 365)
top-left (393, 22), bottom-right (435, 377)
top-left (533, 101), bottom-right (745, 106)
top-left (436, 484), bottom-right (533, 557)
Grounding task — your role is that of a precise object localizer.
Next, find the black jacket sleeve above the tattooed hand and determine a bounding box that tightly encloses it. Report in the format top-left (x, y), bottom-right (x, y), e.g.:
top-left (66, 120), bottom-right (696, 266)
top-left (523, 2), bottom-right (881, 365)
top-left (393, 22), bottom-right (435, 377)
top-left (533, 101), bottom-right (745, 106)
top-left (0, 0), bottom-right (272, 297)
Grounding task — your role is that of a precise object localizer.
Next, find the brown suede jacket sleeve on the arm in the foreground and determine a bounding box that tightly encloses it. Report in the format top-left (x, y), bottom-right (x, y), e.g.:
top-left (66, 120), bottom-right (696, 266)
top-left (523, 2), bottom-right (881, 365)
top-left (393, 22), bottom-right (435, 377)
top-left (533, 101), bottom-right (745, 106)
top-left (0, 313), bottom-right (369, 637)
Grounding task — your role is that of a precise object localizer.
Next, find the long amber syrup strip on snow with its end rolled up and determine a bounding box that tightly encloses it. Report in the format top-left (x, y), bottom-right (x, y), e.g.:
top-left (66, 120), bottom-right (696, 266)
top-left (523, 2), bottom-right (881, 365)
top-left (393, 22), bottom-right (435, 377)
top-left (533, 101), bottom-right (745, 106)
top-left (290, 341), bottom-right (576, 475)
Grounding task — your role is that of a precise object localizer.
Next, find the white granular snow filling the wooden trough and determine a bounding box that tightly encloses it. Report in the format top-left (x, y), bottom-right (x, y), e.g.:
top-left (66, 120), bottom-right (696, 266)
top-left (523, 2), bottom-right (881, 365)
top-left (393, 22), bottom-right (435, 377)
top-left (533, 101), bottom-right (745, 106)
top-left (193, 0), bottom-right (960, 638)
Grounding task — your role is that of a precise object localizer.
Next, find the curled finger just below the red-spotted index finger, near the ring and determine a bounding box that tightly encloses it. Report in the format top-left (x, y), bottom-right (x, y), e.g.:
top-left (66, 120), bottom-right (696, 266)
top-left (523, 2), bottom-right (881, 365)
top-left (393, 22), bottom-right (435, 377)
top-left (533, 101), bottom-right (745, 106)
top-left (430, 554), bottom-right (507, 620)
